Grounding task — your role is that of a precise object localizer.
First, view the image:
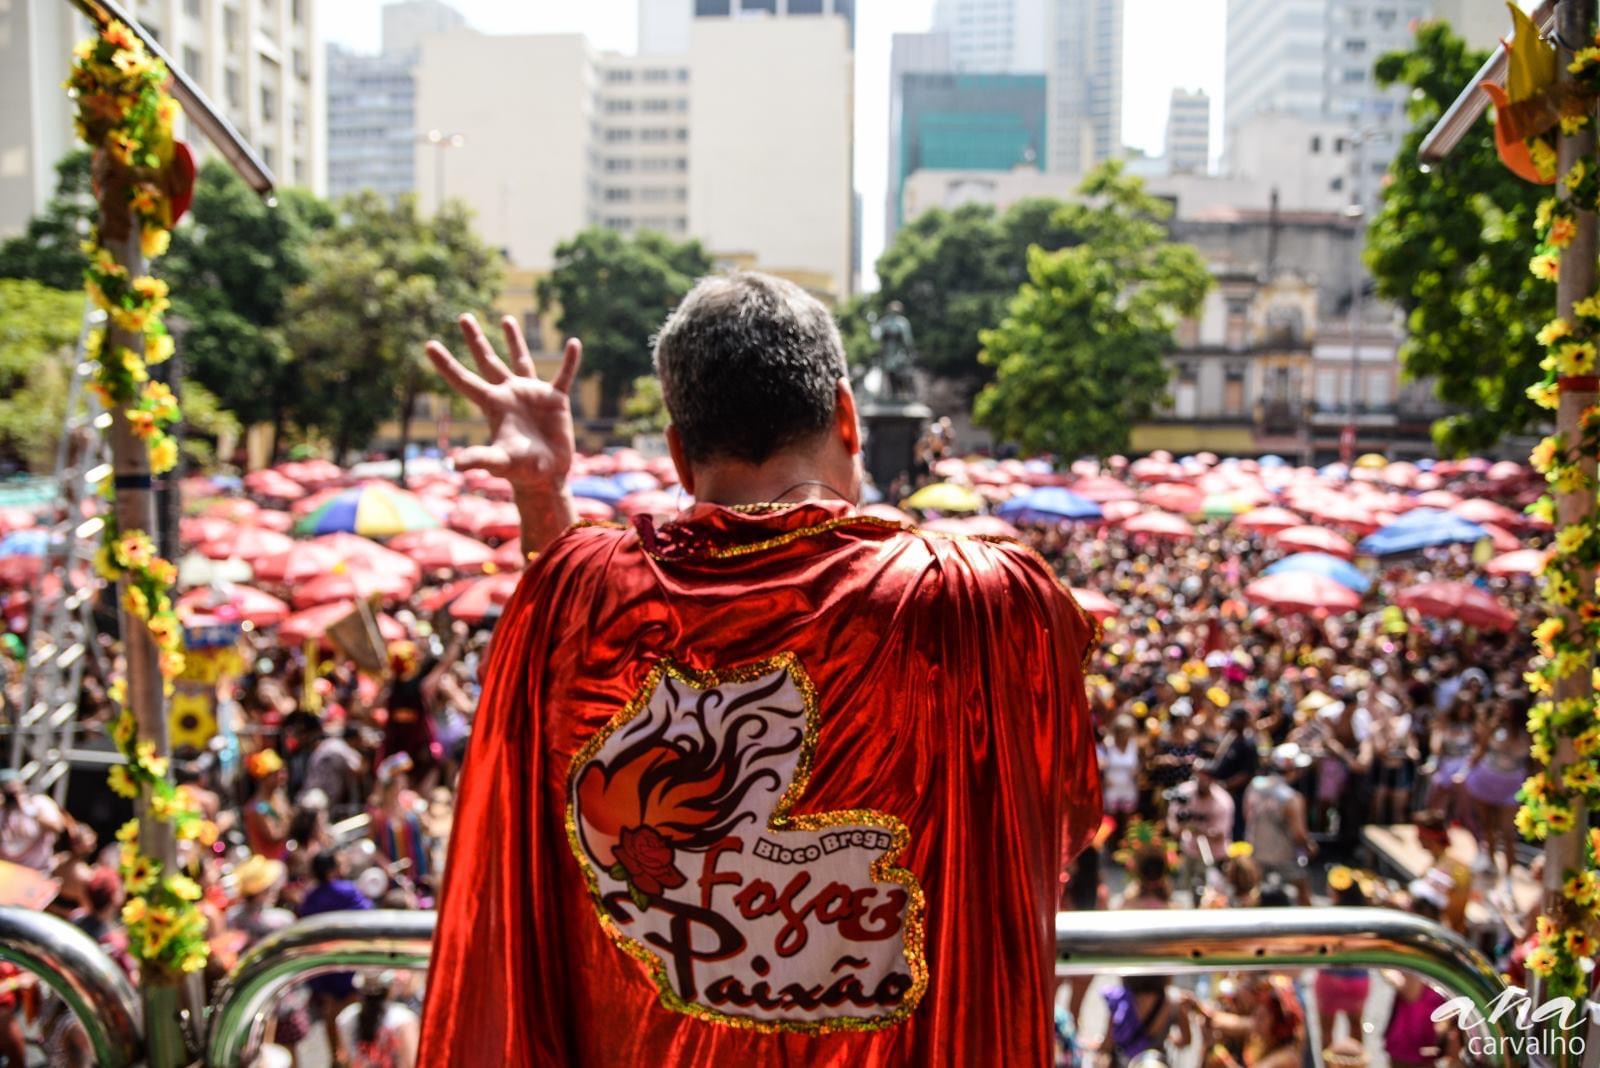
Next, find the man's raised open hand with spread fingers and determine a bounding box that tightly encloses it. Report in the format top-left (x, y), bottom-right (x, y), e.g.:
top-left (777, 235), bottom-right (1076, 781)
top-left (427, 315), bottom-right (584, 496)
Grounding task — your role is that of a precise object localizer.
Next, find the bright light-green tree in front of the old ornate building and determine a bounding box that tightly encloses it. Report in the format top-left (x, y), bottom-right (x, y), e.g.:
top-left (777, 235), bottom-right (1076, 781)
top-left (973, 163), bottom-right (1211, 459)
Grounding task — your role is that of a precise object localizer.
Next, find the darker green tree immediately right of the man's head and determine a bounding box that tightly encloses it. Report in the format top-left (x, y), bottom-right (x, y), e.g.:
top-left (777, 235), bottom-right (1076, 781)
top-left (838, 198), bottom-right (1083, 387)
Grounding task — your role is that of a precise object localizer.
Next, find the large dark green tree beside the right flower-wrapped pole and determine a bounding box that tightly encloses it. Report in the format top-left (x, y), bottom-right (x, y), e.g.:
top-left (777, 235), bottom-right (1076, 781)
top-left (1366, 22), bottom-right (1555, 454)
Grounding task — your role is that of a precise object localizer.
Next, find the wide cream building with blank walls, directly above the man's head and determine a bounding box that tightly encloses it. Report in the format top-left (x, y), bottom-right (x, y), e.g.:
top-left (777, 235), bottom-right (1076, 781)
top-left (416, 13), bottom-right (854, 299)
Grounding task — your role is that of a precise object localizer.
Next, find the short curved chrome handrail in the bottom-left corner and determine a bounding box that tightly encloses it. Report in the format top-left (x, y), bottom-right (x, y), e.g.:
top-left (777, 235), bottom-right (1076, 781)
top-left (0, 907), bottom-right (144, 1068)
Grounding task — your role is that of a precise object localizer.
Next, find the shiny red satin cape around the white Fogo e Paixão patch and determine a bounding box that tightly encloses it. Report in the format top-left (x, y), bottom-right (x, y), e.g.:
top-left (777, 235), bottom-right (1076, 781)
top-left (419, 502), bottom-right (1101, 1066)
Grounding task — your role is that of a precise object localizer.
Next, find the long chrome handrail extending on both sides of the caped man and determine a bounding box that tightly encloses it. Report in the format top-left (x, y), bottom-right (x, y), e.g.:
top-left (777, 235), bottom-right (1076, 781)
top-left (206, 908), bottom-right (1510, 1068)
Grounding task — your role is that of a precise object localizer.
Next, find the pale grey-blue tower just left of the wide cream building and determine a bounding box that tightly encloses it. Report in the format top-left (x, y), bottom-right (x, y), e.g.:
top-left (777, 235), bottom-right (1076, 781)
top-left (328, 0), bottom-right (466, 205)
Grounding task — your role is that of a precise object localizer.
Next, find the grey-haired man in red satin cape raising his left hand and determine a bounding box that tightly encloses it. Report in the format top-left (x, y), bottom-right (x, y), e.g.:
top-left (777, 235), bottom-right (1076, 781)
top-left (421, 273), bottom-right (1101, 1066)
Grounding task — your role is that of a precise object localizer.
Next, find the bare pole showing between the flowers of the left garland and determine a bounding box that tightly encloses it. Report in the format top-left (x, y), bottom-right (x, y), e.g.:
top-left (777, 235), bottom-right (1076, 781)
top-left (102, 225), bottom-right (189, 1068)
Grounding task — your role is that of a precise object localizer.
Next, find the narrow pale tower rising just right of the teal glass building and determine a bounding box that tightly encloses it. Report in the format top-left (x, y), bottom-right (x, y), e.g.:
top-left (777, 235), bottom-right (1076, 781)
top-left (1045, 0), bottom-right (1123, 174)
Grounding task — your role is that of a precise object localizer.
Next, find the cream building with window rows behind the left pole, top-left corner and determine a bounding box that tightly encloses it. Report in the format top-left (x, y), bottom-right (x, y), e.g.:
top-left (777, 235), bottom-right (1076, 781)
top-left (0, 0), bottom-right (326, 235)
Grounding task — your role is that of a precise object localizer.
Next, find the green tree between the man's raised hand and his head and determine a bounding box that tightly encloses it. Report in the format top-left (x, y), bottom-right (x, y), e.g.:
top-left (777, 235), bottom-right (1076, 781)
top-left (538, 227), bottom-right (712, 412)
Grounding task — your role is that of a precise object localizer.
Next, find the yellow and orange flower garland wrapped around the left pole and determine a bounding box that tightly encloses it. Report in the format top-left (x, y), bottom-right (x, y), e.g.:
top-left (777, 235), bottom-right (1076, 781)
top-left (66, 22), bottom-right (216, 974)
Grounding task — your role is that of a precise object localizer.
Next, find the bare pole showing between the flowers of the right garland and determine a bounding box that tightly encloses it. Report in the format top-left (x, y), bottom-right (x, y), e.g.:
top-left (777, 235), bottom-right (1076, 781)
top-left (1544, 0), bottom-right (1595, 1068)
